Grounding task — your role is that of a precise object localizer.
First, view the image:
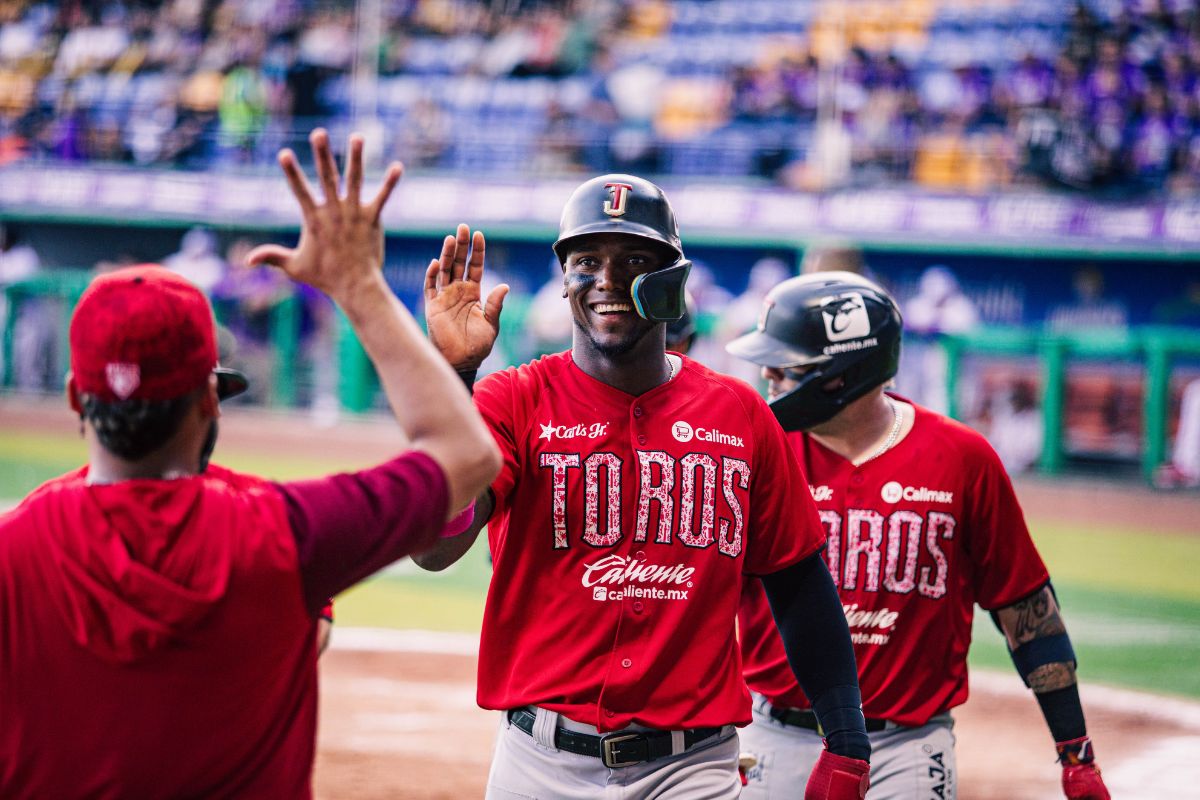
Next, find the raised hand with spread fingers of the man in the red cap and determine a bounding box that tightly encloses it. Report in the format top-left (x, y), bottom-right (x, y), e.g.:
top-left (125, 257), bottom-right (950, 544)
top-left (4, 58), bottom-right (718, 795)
top-left (246, 128), bottom-right (404, 301)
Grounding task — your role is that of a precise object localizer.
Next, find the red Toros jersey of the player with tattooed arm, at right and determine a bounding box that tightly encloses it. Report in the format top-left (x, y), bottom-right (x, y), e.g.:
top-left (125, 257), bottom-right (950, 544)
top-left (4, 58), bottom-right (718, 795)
top-left (739, 398), bottom-right (1049, 726)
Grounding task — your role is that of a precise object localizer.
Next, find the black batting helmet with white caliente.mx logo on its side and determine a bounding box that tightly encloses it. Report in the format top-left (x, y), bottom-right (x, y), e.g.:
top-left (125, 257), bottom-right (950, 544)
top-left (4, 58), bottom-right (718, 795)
top-left (726, 272), bottom-right (902, 431)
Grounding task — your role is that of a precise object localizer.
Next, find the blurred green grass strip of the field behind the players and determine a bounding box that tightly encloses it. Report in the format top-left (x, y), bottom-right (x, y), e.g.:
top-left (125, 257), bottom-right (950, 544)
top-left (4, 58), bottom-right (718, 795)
top-left (0, 431), bottom-right (1200, 697)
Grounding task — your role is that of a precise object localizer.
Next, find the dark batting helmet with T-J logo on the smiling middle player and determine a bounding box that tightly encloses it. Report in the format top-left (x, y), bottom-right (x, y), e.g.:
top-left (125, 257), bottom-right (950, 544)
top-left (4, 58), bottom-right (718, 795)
top-left (554, 175), bottom-right (691, 323)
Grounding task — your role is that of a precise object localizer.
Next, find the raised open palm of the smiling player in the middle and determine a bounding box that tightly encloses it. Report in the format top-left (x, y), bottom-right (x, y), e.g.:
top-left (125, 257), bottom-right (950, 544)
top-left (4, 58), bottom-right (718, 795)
top-left (425, 224), bottom-right (509, 369)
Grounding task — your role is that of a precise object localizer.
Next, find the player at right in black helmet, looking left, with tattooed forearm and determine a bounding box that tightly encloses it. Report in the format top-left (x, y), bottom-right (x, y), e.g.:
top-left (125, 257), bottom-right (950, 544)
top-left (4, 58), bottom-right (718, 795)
top-left (728, 272), bottom-right (1109, 800)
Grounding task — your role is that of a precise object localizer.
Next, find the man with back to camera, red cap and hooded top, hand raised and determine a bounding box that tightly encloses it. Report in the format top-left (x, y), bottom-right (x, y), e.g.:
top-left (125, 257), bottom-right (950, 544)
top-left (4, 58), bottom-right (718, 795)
top-left (0, 131), bottom-right (499, 800)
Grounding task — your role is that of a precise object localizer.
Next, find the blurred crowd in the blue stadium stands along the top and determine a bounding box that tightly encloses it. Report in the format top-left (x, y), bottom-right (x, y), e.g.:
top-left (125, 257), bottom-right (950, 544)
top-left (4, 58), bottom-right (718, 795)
top-left (0, 0), bottom-right (1200, 194)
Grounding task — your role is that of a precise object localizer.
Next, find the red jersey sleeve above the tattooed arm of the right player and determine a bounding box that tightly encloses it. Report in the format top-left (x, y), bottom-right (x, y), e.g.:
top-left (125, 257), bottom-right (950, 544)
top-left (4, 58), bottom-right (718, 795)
top-left (964, 437), bottom-right (1050, 610)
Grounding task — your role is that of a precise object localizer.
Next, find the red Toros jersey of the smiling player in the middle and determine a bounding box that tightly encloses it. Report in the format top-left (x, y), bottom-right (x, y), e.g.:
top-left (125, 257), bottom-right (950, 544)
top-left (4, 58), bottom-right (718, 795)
top-left (475, 353), bottom-right (824, 730)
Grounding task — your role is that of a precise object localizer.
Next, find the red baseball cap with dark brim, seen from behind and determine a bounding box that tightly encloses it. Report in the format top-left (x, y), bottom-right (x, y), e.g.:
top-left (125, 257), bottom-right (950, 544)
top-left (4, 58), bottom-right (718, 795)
top-left (71, 264), bottom-right (247, 403)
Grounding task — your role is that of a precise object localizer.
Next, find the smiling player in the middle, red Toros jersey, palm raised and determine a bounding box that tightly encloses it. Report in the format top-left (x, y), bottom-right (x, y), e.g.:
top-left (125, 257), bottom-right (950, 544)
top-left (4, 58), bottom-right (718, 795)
top-left (414, 175), bottom-right (870, 800)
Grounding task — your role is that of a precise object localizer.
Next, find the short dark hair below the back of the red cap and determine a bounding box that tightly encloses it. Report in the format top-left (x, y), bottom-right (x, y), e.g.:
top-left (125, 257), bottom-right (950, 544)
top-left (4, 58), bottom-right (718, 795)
top-left (79, 392), bottom-right (194, 461)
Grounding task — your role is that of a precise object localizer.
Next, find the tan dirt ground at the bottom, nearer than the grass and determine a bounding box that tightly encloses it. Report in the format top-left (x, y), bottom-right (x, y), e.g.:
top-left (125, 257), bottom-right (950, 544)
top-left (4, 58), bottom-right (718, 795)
top-left (316, 630), bottom-right (1200, 800)
